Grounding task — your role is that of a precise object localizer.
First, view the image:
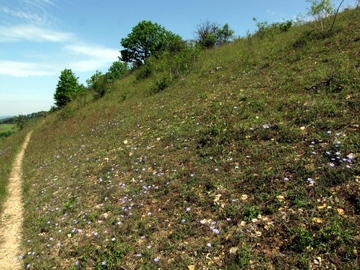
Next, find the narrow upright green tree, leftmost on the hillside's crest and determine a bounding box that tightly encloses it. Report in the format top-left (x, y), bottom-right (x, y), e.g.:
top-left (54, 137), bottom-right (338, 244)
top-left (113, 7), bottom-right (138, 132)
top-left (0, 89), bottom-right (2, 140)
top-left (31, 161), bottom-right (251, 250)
top-left (54, 69), bottom-right (79, 108)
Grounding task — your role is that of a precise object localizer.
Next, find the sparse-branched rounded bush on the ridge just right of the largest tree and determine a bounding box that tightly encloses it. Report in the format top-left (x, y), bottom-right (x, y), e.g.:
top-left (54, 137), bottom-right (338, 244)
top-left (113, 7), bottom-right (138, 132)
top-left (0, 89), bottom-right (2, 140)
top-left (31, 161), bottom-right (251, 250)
top-left (194, 21), bottom-right (234, 48)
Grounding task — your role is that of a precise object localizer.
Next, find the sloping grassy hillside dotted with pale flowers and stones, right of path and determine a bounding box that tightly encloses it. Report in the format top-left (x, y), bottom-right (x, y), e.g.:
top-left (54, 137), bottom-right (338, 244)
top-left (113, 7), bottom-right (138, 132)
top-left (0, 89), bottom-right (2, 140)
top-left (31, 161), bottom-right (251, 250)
top-left (13, 8), bottom-right (360, 269)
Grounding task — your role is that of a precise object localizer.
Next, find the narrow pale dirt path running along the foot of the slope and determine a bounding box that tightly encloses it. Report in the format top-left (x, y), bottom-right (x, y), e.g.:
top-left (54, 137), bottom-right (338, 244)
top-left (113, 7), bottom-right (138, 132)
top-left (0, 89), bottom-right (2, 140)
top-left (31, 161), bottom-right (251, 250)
top-left (0, 131), bottom-right (32, 270)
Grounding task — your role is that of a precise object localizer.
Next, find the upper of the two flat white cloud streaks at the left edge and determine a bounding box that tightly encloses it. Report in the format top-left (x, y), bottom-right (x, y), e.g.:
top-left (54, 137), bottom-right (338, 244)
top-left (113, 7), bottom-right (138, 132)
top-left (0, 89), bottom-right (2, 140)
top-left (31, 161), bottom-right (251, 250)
top-left (0, 25), bottom-right (75, 42)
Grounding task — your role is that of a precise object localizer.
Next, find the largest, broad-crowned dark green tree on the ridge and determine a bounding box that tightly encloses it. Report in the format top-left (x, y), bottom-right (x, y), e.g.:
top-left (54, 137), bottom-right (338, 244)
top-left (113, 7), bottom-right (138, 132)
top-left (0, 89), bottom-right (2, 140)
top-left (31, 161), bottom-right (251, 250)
top-left (120, 21), bottom-right (181, 66)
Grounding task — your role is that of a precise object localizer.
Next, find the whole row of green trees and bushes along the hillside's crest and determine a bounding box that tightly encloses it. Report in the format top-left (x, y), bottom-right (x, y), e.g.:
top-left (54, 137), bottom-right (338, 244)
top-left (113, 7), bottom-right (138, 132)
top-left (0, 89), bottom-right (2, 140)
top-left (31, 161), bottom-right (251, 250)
top-left (50, 0), bottom-right (350, 111)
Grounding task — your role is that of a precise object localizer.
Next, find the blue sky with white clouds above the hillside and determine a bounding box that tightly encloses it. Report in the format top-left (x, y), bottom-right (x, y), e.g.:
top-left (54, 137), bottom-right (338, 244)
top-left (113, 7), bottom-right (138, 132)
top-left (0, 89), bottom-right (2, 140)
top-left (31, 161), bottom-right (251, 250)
top-left (0, 0), bottom-right (355, 116)
